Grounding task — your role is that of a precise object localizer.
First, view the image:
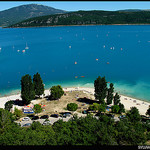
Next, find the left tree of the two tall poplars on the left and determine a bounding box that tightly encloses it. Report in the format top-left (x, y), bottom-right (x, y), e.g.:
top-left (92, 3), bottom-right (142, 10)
top-left (21, 74), bottom-right (35, 105)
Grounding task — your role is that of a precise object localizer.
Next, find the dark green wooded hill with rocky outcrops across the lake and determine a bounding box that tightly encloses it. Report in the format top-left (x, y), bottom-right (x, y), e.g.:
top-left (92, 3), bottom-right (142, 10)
top-left (10, 10), bottom-right (150, 27)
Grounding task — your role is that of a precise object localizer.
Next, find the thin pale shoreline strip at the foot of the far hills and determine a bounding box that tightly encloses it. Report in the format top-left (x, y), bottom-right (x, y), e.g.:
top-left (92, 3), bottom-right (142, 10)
top-left (3, 24), bottom-right (150, 29)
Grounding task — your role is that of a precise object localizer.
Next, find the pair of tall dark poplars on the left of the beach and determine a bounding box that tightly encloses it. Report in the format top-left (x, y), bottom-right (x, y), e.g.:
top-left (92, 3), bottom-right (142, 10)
top-left (21, 73), bottom-right (44, 105)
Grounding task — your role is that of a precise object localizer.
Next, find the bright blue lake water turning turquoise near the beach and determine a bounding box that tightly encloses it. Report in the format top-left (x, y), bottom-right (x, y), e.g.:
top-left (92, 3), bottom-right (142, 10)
top-left (0, 25), bottom-right (150, 101)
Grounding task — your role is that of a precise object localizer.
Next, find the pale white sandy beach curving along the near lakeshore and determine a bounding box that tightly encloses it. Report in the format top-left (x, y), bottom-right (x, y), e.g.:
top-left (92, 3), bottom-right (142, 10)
top-left (0, 87), bottom-right (150, 115)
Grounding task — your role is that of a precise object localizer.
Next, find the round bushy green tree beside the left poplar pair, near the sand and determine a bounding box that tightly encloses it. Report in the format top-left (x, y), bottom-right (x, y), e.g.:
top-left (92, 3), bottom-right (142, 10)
top-left (50, 85), bottom-right (64, 100)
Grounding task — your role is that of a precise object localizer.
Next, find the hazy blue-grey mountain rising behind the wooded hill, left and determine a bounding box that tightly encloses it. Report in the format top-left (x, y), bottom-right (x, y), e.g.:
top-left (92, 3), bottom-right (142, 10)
top-left (0, 4), bottom-right (67, 26)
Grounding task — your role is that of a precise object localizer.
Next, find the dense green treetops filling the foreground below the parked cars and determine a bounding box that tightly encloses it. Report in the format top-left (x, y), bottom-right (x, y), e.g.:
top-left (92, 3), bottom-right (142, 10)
top-left (0, 109), bottom-right (150, 145)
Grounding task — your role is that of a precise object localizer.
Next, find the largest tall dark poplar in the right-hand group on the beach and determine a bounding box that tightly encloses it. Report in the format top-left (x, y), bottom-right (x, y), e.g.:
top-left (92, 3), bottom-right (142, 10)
top-left (94, 76), bottom-right (107, 104)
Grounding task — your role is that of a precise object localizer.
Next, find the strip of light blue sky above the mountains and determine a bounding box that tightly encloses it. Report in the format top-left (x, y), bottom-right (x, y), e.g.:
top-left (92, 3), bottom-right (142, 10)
top-left (0, 1), bottom-right (150, 11)
